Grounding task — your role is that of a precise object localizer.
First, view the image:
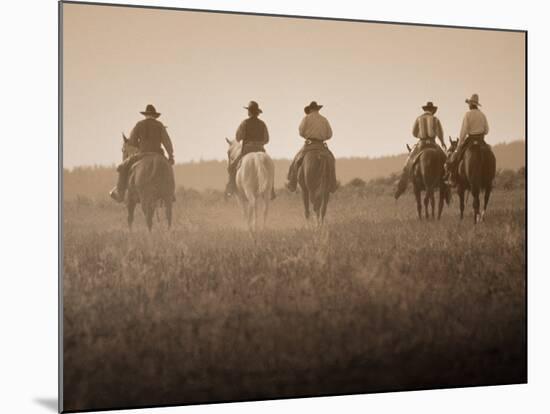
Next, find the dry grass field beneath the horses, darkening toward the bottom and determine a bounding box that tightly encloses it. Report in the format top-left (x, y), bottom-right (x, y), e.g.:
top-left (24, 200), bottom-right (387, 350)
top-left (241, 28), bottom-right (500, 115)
top-left (63, 188), bottom-right (527, 410)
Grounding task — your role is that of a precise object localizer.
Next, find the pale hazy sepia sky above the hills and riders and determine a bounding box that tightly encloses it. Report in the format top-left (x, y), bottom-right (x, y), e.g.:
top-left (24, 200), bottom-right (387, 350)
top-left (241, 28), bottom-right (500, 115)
top-left (63, 4), bottom-right (525, 167)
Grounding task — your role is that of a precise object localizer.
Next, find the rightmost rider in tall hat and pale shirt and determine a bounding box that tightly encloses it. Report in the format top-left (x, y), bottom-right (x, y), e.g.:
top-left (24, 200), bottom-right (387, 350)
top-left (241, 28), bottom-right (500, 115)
top-left (446, 93), bottom-right (489, 186)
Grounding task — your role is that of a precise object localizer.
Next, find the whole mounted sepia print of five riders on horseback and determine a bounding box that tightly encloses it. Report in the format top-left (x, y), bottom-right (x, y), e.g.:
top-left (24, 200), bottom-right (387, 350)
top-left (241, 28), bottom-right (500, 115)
top-left (59, 2), bottom-right (527, 412)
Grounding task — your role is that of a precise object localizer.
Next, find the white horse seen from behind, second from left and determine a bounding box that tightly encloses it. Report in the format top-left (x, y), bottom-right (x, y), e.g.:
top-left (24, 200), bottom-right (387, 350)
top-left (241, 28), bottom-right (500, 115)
top-left (225, 138), bottom-right (275, 232)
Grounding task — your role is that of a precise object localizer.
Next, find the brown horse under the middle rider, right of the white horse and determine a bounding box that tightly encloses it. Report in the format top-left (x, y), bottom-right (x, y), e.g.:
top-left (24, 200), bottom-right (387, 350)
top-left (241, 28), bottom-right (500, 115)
top-left (298, 150), bottom-right (332, 225)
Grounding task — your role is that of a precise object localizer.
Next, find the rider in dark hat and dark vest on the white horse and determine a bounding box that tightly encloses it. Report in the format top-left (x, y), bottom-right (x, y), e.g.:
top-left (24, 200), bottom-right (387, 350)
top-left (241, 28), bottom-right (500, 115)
top-left (225, 101), bottom-right (275, 199)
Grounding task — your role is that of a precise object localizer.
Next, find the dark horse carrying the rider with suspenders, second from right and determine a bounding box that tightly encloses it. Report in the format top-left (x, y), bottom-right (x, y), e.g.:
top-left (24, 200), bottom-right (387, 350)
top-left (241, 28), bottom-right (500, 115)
top-left (407, 145), bottom-right (449, 220)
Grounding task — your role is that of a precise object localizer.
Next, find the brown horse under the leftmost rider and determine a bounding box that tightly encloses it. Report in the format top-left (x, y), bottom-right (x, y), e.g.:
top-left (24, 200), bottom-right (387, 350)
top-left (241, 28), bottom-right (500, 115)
top-left (122, 134), bottom-right (175, 231)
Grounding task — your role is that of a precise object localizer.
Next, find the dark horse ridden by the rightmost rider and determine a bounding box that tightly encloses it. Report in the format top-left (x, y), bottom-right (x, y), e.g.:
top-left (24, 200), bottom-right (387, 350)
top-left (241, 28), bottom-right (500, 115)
top-left (448, 138), bottom-right (496, 223)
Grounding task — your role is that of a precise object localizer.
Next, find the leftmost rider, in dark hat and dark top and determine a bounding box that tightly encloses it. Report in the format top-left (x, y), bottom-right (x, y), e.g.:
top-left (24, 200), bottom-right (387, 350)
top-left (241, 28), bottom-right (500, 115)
top-left (109, 104), bottom-right (174, 203)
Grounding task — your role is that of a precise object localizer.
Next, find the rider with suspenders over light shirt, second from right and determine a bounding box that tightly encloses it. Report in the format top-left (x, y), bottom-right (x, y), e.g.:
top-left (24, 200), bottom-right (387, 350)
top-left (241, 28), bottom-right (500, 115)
top-left (395, 102), bottom-right (447, 200)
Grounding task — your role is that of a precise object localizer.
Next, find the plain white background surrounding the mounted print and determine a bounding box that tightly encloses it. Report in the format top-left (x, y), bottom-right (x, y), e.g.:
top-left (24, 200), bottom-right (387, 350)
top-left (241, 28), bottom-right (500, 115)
top-left (0, 0), bottom-right (550, 414)
